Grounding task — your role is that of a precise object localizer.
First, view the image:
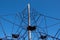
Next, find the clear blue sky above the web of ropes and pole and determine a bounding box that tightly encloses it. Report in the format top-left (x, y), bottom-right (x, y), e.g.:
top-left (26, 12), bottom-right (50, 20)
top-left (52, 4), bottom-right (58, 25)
top-left (0, 0), bottom-right (60, 39)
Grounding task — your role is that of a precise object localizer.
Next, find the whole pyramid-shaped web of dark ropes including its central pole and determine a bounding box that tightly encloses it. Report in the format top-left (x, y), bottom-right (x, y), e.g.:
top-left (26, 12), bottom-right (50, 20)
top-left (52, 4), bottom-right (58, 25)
top-left (0, 3), bottom-right (60, 40)
